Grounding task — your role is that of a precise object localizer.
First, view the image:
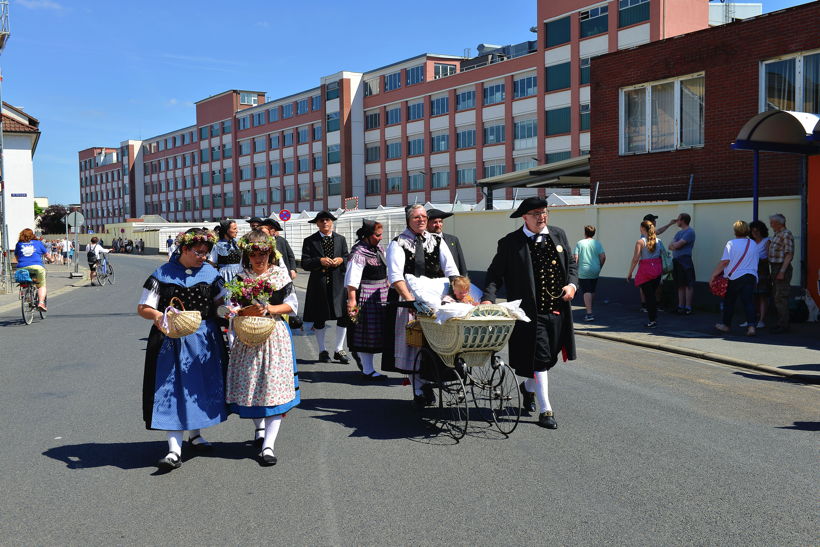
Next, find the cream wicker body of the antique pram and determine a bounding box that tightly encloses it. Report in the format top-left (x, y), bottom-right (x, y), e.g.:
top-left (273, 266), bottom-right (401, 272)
top-left (418, 304), bottom-right (515, 367)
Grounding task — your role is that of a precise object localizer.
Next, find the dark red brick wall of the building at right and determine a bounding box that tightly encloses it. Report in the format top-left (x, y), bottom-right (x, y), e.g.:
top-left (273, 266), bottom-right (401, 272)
top-left (590, 2), bottom-right (820, 203)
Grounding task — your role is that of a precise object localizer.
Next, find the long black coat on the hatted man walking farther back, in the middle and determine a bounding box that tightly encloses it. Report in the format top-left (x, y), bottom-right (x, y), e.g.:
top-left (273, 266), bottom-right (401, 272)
top-left (302, 232), bottom-right (348, 322)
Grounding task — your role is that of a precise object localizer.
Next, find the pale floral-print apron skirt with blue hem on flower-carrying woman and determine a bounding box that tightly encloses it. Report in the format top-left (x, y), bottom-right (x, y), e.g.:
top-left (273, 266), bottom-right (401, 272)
top-left (225, 320), bottom-right (301, 418)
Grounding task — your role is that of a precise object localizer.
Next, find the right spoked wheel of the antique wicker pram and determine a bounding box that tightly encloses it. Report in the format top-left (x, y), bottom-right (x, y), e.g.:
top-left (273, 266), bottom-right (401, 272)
top-left (468, 355), bottom-right (521, 435)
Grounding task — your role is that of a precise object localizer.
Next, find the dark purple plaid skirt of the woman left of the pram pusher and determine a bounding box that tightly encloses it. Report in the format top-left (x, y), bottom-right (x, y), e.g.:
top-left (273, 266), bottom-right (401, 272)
top-left (347, 278), bottom-right (390, 353)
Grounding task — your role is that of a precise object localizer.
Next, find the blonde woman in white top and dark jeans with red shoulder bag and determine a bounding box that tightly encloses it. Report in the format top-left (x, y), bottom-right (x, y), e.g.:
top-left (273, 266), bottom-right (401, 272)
top-left (709, 220), bottom-right (760, 336)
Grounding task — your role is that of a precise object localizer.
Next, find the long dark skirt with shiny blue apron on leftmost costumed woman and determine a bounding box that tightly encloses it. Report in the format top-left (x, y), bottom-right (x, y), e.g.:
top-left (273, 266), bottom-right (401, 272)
top-left (142, 319), bottom-right (228, 431)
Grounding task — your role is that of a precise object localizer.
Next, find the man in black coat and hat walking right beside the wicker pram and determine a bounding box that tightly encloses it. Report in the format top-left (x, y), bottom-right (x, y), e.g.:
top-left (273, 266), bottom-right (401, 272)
top-left (482, 197), bottom-right (578, 429)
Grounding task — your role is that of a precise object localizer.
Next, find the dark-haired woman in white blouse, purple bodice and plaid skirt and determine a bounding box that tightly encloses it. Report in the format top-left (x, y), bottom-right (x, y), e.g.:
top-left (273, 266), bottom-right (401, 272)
top-left (345, 219), bottom-right (390, 381)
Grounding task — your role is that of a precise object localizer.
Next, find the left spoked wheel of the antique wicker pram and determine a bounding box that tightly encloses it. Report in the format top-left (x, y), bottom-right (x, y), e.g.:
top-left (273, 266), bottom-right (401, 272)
top-left (414, 347), bottom-right (469, 440)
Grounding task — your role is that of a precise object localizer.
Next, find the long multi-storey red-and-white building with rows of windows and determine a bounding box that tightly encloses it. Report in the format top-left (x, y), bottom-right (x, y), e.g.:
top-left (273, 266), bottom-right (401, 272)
top-left (80, 0), bottom-right (709, 230)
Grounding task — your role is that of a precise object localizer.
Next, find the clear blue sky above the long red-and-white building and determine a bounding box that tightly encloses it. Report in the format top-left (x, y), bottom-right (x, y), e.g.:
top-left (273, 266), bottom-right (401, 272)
top-left (0, 0), bottom-right (807, 203)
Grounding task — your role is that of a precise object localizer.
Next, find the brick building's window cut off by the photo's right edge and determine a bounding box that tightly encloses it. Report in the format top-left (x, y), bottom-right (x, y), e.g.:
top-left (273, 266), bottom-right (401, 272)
top-left (760, 52), bottom-right (820, 114)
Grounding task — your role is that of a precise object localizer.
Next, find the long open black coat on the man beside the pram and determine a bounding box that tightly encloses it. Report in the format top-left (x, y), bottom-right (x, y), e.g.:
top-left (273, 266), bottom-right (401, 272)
top-left (481, 226), bottom-right (578, 378)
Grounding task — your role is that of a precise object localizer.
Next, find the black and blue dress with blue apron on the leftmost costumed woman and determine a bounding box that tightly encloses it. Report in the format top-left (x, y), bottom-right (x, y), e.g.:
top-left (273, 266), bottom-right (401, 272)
top-left (143, 255), bottom-right (228, 431)
